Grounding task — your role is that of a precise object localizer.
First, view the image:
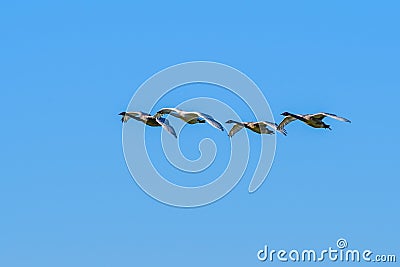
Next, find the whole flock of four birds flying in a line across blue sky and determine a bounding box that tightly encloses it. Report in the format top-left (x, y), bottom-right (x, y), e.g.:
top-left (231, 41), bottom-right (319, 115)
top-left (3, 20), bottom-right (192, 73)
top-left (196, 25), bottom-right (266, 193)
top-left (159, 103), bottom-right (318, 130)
top-left (118, 108), bottom-right (350, 138)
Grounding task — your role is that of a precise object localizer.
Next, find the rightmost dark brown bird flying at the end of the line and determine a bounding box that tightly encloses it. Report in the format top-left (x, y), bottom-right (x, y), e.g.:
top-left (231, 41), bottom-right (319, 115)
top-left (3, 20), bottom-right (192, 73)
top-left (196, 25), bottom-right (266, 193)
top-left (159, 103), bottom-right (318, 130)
top-left (278, 112), bottom-right (351, 130)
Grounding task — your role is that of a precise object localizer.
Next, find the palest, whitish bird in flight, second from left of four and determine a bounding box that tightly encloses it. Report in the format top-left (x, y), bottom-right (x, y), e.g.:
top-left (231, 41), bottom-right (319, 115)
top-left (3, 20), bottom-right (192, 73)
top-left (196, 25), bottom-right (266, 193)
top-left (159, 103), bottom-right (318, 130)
top-left (154, 108), bottom-right (224, 131)
